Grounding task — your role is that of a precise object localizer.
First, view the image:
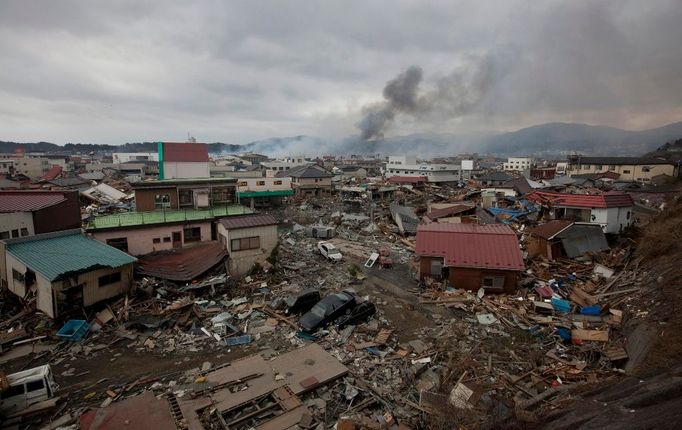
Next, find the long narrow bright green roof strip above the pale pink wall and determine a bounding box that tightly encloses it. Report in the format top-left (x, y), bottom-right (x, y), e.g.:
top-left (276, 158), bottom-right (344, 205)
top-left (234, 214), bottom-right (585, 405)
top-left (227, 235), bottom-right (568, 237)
top-left (87, 205), bottom-right (253, 231)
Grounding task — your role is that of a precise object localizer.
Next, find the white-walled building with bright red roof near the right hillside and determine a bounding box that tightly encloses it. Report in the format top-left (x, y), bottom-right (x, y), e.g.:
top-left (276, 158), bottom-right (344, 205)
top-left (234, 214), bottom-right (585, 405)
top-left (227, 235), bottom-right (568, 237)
top-left (526, 191), bottom-right (635, 234)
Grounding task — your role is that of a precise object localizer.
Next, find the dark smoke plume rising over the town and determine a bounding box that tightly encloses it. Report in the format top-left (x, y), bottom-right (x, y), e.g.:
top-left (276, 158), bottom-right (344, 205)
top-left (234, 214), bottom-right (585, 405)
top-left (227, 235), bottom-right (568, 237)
top-left (357, 56), bottom-right (496, 140)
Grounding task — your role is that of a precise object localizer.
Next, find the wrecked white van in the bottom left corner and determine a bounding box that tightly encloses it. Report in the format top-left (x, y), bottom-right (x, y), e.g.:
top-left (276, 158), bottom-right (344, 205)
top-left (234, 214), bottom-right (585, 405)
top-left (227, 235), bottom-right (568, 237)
top-left (0, 364), bottom-right (59, 414)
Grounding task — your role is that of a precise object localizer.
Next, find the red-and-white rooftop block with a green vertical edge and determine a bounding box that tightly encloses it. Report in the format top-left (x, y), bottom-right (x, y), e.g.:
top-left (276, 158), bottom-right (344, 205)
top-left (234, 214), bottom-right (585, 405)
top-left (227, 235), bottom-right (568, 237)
top-left (158, 142), bottom-right (211, 179)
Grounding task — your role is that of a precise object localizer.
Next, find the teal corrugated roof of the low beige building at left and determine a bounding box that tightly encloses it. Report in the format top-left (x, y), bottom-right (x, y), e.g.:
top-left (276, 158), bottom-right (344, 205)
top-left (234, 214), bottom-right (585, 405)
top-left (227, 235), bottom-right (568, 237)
top-left (6, 230), bottom-right (137, 282)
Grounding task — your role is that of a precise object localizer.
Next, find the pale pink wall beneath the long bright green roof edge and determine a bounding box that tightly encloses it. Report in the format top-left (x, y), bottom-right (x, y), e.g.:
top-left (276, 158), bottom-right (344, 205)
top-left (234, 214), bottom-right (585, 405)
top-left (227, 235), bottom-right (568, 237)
top-left (89, 222), bottom-right (211, 255)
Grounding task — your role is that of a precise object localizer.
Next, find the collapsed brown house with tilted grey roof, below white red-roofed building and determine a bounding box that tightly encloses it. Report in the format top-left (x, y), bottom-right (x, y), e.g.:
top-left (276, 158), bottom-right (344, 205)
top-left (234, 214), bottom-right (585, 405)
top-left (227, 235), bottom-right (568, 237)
top-left (526, 220), bottom-right (609, 260)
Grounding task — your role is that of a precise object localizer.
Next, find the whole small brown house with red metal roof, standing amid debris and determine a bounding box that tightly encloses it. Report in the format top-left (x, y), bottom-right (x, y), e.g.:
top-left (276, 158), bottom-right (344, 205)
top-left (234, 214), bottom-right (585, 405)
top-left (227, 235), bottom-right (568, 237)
top-left (416, 223), bottom-right (525, 293)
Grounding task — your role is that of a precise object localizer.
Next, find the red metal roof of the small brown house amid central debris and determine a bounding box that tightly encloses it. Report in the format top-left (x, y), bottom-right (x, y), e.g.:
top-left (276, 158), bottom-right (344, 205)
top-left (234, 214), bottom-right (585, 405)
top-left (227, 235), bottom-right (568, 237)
top-left (416, 223), bottom-right (525, 270)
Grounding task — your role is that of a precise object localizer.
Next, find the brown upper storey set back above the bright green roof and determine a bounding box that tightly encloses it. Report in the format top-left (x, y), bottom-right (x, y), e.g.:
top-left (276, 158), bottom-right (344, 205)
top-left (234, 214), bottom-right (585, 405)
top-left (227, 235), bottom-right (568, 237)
top-left (131, 177), bottom-right (238, 212)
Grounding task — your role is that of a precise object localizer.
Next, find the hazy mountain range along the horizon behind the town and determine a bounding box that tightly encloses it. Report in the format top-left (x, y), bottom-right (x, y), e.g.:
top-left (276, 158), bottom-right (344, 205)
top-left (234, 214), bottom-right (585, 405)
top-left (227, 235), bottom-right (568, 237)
top-left (0, 122), bottom-right (682, 158)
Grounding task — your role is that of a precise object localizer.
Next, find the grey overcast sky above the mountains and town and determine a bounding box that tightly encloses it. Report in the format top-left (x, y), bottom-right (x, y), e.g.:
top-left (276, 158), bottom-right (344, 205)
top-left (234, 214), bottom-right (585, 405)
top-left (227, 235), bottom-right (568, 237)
top-left (0, 0), bottom-right (682, 144)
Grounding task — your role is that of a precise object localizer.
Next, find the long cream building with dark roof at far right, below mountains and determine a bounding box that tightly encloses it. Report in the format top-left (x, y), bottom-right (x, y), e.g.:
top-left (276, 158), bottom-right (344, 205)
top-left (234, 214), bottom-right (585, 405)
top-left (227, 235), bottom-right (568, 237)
top-left (567, 155), bottom-right (679, 182)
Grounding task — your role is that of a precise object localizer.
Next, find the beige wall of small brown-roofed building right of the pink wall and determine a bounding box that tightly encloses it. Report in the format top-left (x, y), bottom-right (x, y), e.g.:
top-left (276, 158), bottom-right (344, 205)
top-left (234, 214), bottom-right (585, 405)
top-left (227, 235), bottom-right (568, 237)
top-left (218, 223), bottom-right (279, 277)
